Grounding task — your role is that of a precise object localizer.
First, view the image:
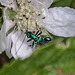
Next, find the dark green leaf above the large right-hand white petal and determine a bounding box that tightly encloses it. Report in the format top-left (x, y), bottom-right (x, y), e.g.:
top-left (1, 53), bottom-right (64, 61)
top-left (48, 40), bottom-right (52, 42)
top-left (50, 0), bottom-right (72, 8)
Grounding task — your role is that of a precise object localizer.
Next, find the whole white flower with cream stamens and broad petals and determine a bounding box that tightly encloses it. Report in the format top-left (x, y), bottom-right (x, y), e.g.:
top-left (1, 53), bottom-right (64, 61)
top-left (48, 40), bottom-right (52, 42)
top-left (0, 0), bottom-right (75, 59)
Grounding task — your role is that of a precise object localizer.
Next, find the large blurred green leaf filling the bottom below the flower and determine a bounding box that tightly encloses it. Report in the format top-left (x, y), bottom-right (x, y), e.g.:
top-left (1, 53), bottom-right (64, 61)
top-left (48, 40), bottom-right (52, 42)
top-left (0, 37), bottom-right (75, 75)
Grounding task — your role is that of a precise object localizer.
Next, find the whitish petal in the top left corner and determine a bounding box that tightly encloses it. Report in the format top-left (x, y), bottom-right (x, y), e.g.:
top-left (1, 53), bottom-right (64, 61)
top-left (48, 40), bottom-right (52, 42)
top-left (0, 0), bottom-right (17, 10)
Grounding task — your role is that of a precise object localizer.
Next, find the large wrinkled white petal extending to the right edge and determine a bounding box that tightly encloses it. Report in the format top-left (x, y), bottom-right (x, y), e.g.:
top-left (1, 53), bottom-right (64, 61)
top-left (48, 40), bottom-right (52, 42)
top-left (43, 7), bottom-right (75, 37)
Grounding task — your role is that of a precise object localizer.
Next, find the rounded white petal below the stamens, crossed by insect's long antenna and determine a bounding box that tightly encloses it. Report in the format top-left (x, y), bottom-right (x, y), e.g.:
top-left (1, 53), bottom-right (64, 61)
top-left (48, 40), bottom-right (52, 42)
top-left (11, 32), bottom-right (33, 60)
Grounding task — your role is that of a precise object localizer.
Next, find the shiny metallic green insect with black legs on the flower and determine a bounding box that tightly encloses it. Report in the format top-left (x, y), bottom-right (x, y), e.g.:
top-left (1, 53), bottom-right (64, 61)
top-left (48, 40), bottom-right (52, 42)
top-left (25, 30), bottom-right (52, 48)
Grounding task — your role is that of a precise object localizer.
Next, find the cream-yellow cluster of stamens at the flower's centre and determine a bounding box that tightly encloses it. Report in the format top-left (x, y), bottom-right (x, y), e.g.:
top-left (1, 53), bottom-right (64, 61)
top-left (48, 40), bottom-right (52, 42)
top-left (16, 0), bottom-right (43, 32)
